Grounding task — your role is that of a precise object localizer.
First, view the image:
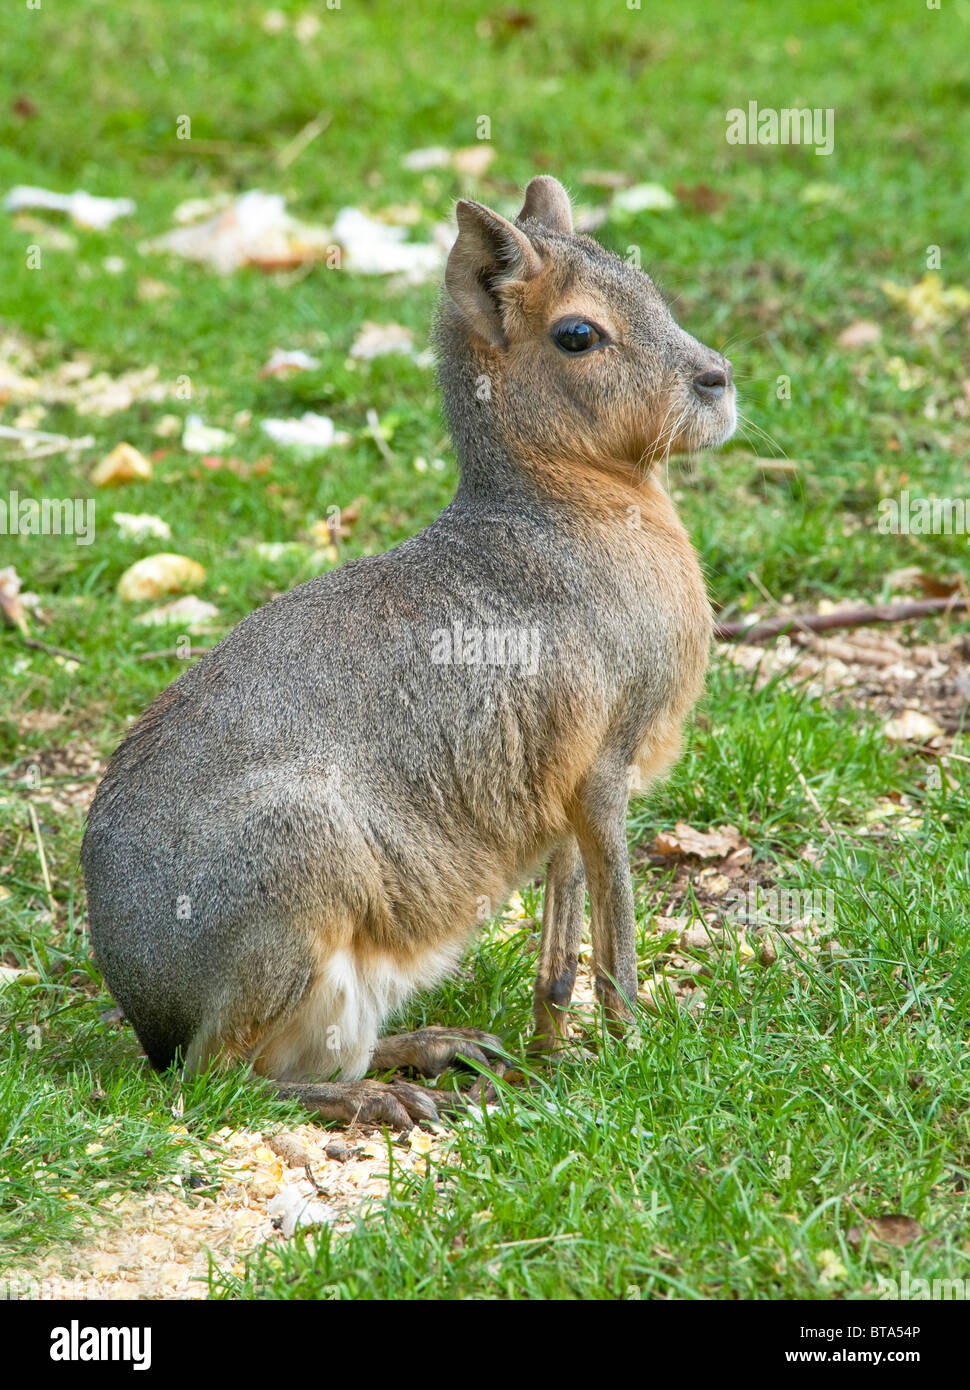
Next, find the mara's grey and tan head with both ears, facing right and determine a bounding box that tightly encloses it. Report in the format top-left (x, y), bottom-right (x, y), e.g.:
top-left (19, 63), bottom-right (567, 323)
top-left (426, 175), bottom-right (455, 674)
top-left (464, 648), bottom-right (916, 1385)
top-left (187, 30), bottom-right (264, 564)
top-left (438, 175), bottom-right (737, 474)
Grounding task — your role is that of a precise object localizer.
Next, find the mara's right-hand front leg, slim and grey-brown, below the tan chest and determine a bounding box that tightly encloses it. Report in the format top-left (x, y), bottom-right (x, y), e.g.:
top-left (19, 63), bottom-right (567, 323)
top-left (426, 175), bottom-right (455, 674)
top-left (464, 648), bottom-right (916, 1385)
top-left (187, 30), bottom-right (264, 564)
top-left (575, 769), bottom-right (636, 1031)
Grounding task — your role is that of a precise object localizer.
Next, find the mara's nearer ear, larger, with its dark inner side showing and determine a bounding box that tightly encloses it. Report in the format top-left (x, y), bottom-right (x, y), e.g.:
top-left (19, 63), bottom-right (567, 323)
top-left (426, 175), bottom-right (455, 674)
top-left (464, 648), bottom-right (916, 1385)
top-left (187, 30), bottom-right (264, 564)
top-left (445, 199), bottom-right (542, 348)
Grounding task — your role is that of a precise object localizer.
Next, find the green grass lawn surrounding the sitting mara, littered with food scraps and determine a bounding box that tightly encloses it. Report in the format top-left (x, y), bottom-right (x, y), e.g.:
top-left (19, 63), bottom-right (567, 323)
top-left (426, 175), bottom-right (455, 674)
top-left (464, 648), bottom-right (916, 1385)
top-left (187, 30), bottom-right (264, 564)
top-left (0, 0), bottom-right (970, 1298)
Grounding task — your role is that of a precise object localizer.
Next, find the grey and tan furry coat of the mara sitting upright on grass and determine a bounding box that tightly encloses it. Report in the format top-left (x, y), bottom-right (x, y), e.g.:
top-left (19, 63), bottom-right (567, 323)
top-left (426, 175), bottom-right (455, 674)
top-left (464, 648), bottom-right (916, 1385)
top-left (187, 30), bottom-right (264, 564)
top-left (82, 181), bottom-right (732, 1113)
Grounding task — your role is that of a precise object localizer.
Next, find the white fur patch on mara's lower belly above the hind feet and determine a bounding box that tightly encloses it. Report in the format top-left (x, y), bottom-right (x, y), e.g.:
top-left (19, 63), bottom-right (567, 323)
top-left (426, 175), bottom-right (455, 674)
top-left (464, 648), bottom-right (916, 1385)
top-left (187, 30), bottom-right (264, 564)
top-left (257, 944), bottom-right (460, 1081)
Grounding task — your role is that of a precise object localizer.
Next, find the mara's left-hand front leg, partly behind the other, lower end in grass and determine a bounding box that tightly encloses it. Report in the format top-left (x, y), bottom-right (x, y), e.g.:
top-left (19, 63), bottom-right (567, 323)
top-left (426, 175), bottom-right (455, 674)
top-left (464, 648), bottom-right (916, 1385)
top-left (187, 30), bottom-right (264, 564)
top-left (529, 835), bottom-right (586, 1052)
